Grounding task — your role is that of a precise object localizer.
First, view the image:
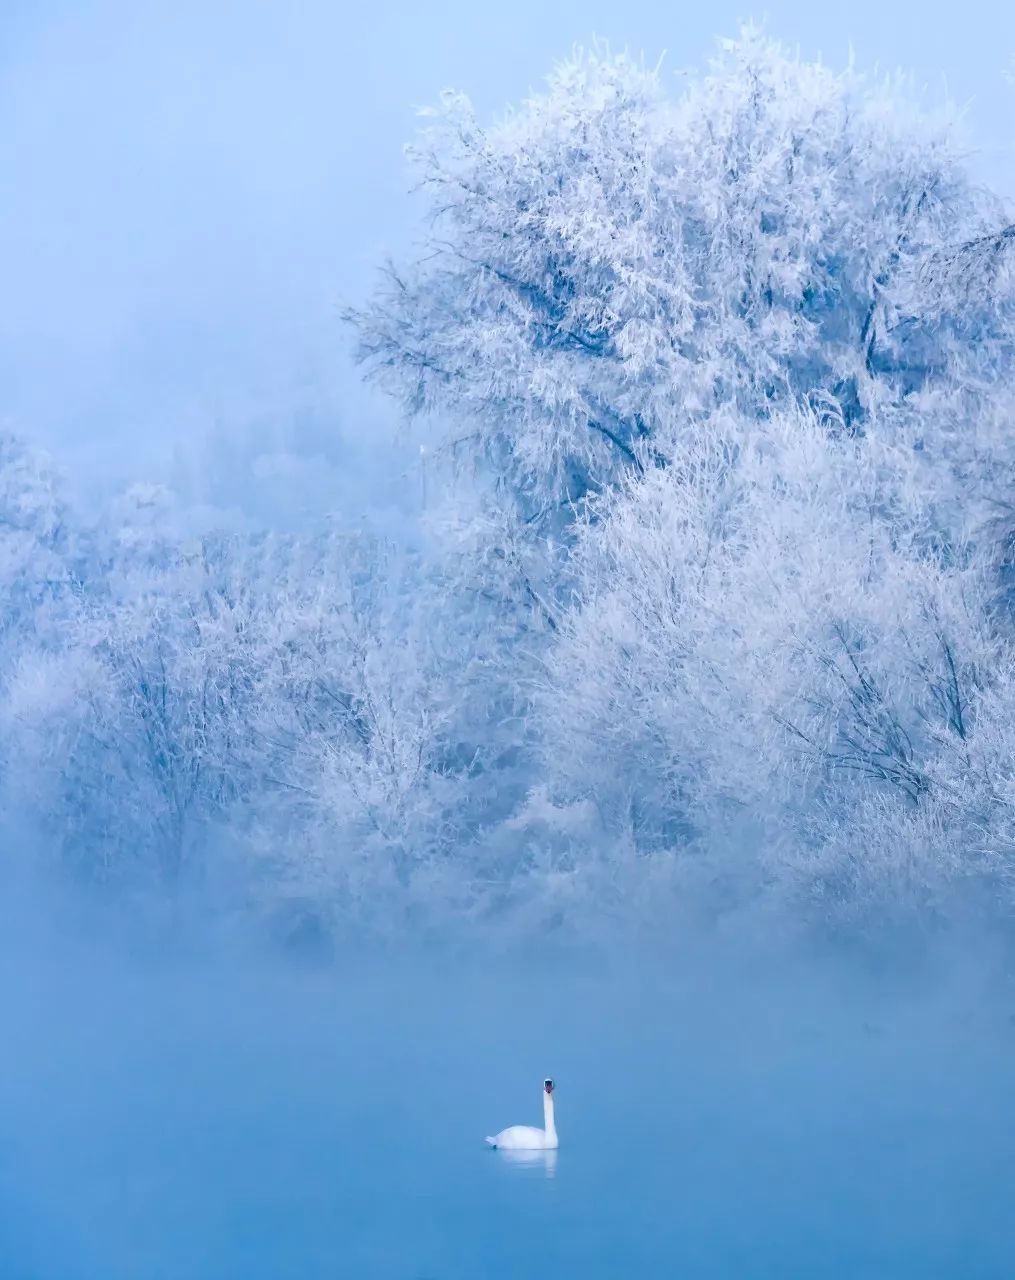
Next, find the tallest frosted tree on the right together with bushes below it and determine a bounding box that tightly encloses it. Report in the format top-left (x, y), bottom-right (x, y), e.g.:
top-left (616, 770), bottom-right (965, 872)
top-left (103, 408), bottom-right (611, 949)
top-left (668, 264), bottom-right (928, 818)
top-left (352, 29), bottom-right (1015, 931)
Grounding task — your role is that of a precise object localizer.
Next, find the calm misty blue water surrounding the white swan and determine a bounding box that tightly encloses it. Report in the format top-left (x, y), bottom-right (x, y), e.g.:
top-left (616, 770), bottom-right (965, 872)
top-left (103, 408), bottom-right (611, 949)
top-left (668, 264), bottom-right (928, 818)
top-left (0, 947), bottom-right (1015, 1280)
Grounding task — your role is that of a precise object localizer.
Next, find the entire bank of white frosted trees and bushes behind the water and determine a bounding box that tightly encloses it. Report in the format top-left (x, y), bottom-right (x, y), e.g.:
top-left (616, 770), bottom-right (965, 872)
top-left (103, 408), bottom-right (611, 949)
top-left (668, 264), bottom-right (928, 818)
top-left (0, 28), bottom-right (1015, 938)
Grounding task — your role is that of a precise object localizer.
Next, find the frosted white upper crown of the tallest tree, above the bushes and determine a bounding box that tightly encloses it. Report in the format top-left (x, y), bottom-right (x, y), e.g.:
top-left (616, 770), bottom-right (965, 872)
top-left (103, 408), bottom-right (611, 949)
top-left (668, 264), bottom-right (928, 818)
top-left (353, 31), bottom-right (997, 509)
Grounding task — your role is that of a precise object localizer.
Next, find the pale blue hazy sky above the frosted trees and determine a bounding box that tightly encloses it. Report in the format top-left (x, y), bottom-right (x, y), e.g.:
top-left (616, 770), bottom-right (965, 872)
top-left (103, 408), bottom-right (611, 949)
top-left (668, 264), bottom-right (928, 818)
top-left (0, 0), bottom-right (1015, 472)
